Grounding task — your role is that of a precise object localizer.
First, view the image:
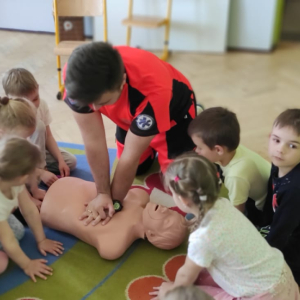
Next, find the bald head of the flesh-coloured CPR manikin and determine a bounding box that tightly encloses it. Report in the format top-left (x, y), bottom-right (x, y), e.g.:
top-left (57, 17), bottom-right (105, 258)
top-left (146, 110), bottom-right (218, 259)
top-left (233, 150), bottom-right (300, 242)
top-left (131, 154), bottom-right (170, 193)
top-left (143, 202), bottom-right (187, 250)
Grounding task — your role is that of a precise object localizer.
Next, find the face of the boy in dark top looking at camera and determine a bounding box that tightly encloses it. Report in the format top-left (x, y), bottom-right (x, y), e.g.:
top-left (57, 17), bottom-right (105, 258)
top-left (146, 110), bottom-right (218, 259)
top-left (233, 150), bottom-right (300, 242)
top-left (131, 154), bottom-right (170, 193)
top-left (269, 126), bottom-right (300, 170)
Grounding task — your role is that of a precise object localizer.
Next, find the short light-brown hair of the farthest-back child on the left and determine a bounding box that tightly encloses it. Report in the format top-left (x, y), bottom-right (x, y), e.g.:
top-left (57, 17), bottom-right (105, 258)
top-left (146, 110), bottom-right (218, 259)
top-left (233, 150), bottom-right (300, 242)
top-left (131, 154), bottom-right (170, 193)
top-left (2, 68), bottom-right (38, 97)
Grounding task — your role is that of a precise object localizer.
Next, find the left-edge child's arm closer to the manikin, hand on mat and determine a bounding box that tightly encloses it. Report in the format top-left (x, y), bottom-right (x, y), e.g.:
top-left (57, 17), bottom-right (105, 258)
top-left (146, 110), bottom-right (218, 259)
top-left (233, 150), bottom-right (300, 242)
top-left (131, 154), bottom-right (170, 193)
top-left (19, 189), bottom-right (63, 256)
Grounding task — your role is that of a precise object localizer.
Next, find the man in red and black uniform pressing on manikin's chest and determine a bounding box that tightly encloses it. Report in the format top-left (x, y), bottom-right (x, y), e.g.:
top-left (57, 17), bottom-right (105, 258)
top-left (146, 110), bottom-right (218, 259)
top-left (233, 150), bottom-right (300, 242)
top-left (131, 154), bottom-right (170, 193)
top-left (63, 42), bottom-right (196, 225)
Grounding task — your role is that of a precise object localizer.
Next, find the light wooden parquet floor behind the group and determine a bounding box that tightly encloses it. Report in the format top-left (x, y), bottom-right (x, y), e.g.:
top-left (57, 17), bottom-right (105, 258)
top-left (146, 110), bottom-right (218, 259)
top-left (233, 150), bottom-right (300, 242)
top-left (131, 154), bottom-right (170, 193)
top-left (0, 31), bottom-right (300, 157)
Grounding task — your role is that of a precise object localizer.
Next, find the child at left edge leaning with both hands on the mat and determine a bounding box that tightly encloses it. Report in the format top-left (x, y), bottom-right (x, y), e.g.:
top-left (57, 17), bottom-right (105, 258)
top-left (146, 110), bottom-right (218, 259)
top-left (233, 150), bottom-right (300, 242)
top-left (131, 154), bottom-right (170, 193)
top-left (0, 137), bottom-right (63, 282)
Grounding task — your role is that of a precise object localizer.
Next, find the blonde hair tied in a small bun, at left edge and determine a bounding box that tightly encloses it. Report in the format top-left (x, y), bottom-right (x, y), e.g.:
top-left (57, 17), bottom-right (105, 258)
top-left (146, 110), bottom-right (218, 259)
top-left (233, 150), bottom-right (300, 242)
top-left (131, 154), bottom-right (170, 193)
top-left (0, 97), bottom-right (36, 130)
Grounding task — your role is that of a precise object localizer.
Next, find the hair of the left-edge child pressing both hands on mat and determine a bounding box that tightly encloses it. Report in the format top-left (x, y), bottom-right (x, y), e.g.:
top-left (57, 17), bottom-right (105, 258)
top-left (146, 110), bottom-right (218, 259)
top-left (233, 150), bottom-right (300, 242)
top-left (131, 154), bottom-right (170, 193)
top-left (0, 137), bottom-right (41, 180)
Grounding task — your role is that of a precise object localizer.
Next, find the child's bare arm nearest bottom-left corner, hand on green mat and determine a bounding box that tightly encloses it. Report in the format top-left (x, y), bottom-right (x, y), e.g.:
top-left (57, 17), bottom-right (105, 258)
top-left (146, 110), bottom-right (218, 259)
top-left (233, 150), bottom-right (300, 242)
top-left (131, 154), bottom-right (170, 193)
top-left (0, 220), bottom-right (53, 282)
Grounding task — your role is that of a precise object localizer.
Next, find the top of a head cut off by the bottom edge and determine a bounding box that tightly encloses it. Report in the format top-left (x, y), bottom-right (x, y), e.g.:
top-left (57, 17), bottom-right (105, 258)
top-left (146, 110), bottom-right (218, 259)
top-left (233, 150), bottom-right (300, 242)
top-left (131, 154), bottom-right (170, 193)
top-left (163, 285), bottom-right (214, 300)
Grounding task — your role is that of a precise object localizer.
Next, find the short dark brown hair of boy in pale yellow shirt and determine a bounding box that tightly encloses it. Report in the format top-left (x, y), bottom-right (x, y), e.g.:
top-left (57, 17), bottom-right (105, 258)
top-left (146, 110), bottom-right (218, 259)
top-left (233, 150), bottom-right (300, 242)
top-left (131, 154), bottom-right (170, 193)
top-left (188, 107), bottom-right (240, 151)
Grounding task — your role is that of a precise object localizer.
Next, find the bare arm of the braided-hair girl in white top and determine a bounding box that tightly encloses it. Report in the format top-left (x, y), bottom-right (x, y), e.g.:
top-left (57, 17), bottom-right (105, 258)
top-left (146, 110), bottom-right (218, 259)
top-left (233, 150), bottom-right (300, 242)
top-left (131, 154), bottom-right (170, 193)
top-left (149, 256), bottom-right (203, 299)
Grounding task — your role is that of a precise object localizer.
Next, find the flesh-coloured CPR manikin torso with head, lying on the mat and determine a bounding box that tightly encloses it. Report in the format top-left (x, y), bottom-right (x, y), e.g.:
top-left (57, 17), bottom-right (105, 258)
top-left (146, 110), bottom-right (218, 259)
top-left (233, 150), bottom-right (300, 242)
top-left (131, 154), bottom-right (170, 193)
top-left (41, 177), bottom-right (187, 260)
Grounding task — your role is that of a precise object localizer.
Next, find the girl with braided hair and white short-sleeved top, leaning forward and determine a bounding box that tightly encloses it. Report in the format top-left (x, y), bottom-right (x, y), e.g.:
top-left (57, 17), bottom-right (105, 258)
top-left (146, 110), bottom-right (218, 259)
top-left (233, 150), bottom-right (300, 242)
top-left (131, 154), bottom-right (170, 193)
top-left (151, 153), bottom-right (300, 300)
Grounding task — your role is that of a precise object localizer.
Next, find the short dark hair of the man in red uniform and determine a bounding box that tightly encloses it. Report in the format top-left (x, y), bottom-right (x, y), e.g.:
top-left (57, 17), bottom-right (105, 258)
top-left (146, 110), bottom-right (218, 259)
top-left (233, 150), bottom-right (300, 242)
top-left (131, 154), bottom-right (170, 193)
top-left (65, 42), bottom-right (124, 105)
